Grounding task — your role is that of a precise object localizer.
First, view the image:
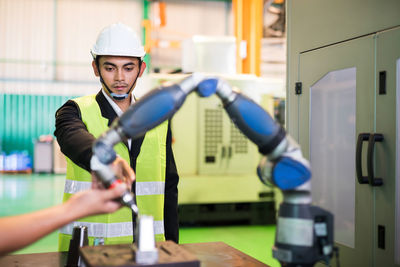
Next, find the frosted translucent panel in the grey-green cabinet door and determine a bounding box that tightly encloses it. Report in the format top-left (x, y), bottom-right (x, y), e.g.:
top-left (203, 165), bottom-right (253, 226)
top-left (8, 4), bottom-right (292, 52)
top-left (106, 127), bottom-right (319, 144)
top-left (310, 68), bottom-right (356, 248)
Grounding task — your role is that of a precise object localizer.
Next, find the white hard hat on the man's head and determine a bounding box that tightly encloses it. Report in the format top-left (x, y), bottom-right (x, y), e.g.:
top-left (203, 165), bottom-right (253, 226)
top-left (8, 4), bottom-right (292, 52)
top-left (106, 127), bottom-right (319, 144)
top-left (90, 23), bottom-right (146, 58)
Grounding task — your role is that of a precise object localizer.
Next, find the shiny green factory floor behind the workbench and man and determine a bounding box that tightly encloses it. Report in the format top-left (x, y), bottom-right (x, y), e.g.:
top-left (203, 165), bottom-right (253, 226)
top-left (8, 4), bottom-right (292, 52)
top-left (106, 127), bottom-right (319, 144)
top-left (0, 174), bottom-right (280, 266)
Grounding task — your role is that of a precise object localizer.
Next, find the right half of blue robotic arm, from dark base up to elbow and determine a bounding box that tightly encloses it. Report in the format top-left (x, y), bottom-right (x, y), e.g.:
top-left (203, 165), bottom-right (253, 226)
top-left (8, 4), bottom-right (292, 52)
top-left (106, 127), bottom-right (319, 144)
top-left (208, 80), bottom-right (333, 266)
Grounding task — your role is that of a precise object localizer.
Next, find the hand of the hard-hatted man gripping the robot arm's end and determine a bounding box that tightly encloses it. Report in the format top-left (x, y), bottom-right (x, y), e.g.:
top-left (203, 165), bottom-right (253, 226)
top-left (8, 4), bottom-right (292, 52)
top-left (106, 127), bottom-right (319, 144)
top-left (92, 156), bottom-right (136, 190)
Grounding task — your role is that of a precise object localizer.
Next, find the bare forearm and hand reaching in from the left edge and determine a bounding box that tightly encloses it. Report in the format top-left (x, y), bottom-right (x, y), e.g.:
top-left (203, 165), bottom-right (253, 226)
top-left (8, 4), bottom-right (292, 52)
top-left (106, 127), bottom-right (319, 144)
top-left (0, 185), bottom-right (126, 255)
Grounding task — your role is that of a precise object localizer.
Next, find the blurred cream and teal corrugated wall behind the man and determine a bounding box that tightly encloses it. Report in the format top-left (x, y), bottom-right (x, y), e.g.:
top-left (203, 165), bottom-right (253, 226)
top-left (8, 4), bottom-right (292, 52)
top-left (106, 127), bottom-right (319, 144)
top-left (0, 0), bottom-right (236, 158)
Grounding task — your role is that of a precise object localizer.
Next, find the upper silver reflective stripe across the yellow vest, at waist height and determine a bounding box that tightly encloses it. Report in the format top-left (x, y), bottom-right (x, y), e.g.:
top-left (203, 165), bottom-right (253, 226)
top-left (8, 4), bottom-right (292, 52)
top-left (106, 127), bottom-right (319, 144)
top-left (64, 180), bottom-right (165, 196)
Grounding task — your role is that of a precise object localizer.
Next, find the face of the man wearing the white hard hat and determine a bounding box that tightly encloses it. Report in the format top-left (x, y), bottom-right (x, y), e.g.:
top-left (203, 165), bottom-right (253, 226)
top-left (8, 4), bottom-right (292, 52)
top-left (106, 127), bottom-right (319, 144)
top-left (92, 56), bottom-right (145, 97)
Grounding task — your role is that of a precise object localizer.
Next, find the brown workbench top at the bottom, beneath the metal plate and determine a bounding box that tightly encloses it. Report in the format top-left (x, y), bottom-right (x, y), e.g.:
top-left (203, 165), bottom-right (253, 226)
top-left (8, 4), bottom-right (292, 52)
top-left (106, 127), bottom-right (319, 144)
top-left (0, 242), bottom-right (268, 267)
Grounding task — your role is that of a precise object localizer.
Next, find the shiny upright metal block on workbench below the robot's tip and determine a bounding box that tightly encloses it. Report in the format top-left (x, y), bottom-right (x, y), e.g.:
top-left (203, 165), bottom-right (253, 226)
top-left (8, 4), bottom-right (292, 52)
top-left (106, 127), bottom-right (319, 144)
top-left (135, 215), bottom-right (158, 264)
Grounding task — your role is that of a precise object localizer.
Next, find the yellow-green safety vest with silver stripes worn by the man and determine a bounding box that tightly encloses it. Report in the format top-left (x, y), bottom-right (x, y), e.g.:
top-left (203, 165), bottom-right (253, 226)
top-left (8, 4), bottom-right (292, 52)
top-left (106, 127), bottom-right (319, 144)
top-left (59, 95), bottom-right (168, 251)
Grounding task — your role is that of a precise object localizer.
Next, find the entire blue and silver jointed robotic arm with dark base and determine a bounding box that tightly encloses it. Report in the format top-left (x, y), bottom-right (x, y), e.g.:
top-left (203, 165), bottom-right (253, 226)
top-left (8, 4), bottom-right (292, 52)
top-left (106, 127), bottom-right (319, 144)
top-left (92, 73), bottom-right (333, 266)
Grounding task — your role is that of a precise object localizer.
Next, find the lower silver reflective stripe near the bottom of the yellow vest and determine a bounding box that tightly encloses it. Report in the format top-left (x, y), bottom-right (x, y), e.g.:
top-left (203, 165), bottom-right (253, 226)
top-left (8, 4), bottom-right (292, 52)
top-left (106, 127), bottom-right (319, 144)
top-left (60, 221), bottom-right (164, 238)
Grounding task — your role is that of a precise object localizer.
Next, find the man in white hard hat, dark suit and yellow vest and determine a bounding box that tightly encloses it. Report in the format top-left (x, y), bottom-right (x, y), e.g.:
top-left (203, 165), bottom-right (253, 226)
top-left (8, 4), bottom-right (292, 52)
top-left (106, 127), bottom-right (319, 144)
top-left (54, 23), bottom-right (179, 251)
